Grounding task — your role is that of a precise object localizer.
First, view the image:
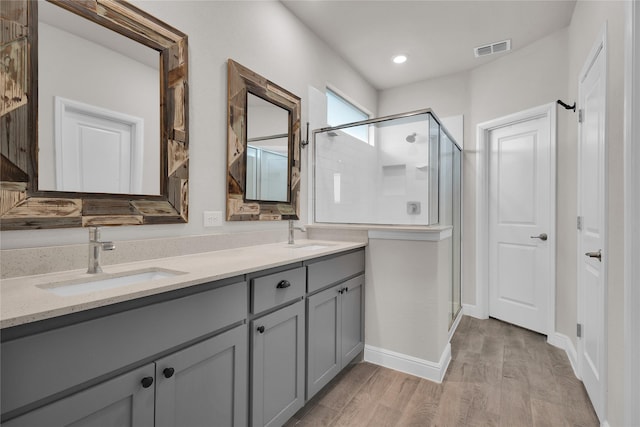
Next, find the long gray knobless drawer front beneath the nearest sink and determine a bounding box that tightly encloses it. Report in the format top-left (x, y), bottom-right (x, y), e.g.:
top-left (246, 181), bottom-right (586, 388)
top-left (0, 282), bottom-right (247, 413)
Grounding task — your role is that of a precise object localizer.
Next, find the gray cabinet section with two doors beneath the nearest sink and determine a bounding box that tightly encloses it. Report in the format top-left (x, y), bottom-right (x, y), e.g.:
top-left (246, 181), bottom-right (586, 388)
top-left (1, 278), bottom-right (248, 427)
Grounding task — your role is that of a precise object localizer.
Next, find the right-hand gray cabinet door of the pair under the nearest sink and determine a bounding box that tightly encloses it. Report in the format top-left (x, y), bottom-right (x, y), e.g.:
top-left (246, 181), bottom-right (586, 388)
top-left (156, 325), bottom-right (248, 427)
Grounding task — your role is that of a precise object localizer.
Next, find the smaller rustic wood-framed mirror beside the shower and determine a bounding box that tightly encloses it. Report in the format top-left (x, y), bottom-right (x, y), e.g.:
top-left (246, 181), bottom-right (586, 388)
top-left (227, 59), bottom-right (300, 221)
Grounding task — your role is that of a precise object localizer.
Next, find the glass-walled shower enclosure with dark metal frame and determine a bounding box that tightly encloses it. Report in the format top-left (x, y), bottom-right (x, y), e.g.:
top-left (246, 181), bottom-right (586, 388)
top-left (313, 109), bottom-right (462, 323)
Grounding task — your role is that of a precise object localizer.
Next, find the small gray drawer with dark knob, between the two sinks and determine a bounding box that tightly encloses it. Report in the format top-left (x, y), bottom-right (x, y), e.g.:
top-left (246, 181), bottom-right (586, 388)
top-left (251, 267), bottom-right (307, 314)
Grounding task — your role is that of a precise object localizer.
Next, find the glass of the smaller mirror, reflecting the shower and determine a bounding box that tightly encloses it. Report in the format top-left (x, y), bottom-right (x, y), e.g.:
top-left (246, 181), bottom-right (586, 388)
top-left (245, 93), bottom-right (289, 202)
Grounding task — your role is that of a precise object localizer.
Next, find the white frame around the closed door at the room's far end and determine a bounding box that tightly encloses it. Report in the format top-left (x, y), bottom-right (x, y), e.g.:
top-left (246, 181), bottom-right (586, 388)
top-left (472, 102), bottom-right (557, 340)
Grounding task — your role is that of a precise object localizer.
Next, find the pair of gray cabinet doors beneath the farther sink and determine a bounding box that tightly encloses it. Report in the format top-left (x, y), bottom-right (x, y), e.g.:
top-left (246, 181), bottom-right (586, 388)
top-left (307, 276), bottom-right (364, 399)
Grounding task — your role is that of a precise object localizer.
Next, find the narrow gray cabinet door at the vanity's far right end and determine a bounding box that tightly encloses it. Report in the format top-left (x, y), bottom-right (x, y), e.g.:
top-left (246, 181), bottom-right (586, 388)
top-left (340, 276), bottom-right (364, 367)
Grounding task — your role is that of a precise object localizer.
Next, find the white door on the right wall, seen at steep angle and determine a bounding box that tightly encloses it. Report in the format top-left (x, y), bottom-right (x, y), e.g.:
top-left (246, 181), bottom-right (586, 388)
top-left (578, 28), bottom-right (607, 420)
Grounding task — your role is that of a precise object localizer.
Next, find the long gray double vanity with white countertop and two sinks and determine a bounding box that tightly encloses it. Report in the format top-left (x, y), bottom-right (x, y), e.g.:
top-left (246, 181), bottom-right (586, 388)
top-left (0, 241), bottom-right (365, 427)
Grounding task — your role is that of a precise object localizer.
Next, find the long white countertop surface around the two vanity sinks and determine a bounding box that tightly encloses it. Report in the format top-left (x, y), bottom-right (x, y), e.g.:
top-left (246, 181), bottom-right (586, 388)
top-left (0, 240), bottom-right (365, 329)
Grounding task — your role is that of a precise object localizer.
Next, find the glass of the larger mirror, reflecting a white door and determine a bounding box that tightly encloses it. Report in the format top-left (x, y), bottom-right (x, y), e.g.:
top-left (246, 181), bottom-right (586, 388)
top-left (38, 2), bottom-right (160, 195)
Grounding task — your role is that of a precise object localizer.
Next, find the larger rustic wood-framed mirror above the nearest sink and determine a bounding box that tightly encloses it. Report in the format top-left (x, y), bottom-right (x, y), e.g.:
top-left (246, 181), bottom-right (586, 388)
top-left (0, 0), bottom-right (189, 230)
